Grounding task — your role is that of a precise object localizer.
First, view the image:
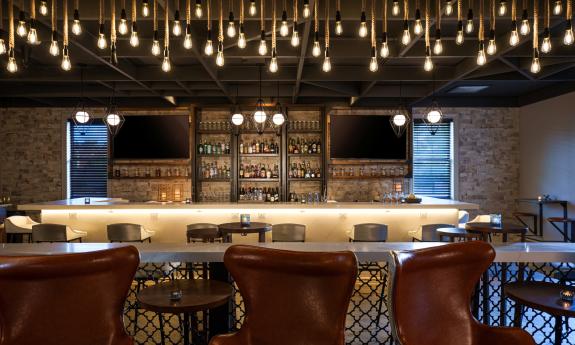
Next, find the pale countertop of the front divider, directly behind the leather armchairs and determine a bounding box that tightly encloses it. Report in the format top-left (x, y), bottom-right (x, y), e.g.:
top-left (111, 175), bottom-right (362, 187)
top-left (0, 242), bottom-right (575, 263)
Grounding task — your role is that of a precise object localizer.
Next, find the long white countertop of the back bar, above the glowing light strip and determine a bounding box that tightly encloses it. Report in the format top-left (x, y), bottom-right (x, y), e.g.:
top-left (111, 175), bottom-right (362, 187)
top-left (18, 197), bottom-right (479, 211)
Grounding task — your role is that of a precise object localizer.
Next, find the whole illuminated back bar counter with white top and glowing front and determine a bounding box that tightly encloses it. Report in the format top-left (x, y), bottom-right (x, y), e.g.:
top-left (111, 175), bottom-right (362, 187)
top-left (18, 197), bottom-right (479, 243)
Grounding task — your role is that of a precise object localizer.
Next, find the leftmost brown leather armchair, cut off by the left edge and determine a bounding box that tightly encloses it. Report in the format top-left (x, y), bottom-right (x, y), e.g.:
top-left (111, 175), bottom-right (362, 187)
top-left (0, 246), bottom-right (140, 345)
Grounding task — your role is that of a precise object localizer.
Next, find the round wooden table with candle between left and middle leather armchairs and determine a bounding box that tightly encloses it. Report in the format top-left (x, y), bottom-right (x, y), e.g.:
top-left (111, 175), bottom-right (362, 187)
top-left (138, 279), bottom-right (233, 345)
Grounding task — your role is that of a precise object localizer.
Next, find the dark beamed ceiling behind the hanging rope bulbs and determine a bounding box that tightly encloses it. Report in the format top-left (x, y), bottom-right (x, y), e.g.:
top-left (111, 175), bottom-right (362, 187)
top-left (0, 0), bottom-right (575, 107)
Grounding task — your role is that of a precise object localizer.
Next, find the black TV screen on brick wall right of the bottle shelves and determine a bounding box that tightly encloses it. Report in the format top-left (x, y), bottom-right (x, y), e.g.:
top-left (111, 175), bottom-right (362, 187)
top-left (329, 115), bottom-right (408, 160)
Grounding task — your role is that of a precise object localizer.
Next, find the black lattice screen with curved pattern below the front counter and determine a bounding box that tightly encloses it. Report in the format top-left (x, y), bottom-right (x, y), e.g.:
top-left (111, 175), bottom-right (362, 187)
top-left (124, 262), bottom-right (575, 345)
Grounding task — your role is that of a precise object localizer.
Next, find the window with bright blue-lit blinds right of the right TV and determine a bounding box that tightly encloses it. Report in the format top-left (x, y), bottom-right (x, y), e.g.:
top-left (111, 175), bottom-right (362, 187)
top-left (413, 121), bottom-right (454, 199)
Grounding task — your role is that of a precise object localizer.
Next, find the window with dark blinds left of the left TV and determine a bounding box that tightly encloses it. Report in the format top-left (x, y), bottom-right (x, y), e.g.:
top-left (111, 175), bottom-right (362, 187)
top-left (66, 121), bottom-right (108, 198)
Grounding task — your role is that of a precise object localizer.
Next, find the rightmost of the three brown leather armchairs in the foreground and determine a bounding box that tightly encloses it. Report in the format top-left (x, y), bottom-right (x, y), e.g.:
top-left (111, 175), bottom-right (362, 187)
top-left (391, 241), bottom-right (535, 345)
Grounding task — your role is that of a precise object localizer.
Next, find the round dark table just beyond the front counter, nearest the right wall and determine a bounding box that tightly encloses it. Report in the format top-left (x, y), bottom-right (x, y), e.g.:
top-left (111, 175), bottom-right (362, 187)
top-left (465, 222), bottom-right (527, 326)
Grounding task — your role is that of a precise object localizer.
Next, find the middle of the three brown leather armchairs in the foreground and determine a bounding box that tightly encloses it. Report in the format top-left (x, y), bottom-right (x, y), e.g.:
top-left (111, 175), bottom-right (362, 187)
top-left (210, 246), bottom-right (357, 345)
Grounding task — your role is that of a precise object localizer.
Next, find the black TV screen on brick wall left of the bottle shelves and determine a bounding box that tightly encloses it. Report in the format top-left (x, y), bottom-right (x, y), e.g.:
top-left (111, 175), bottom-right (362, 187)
top-left (112, 115), bottom-right (190, 159)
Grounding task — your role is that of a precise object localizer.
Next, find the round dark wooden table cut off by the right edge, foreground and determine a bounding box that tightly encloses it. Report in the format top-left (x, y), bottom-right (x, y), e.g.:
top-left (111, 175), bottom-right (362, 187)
top-left (503, 282), bottom-right (575, 345)
